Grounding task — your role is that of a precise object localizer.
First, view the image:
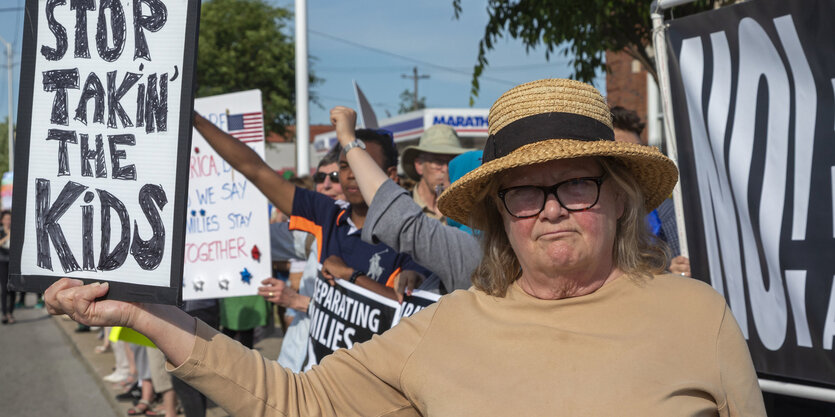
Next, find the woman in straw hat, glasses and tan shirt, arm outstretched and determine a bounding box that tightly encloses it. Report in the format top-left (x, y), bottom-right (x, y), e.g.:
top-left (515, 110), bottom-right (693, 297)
top-left (47, 80), bottom-right (765, 416)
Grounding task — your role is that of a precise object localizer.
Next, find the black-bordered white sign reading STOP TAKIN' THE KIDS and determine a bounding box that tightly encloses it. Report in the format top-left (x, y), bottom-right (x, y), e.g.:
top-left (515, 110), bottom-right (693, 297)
top-left (10, 0), bottom-right (200, 304)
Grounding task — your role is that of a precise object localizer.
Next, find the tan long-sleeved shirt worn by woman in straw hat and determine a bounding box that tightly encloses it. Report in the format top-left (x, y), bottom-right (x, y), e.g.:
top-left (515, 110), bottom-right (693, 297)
top-left (173, 275), bottom-right (765, 416)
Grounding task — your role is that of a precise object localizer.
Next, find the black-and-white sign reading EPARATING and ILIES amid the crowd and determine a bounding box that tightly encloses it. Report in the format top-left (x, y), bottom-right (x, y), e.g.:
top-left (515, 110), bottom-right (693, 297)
top-left (304, 275), bottom-right (440, 370)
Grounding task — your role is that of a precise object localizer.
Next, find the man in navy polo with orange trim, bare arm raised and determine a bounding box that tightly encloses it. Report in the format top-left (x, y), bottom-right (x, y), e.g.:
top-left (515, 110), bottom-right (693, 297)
top-left (194, 113), bottom-right (429, 299)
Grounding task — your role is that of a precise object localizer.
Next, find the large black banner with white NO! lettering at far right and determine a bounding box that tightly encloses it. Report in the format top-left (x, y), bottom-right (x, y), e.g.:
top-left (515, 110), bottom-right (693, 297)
top-left (667, 0), bottom-right (835, 384)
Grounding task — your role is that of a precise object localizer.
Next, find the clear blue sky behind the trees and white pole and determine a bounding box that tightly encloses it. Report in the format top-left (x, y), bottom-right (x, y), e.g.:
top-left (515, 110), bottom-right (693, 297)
top-left (0, 0), bottom-right (605, 124)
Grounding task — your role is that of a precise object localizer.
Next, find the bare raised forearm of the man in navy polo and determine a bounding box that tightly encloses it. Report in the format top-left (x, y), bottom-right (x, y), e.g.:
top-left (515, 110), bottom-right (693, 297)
top-left (194, 112), bottom-right (296, 216)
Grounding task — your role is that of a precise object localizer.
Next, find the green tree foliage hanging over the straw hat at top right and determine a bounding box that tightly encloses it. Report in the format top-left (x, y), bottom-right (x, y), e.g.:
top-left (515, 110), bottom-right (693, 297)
top-left (452, 0), bottom-right (733, 103)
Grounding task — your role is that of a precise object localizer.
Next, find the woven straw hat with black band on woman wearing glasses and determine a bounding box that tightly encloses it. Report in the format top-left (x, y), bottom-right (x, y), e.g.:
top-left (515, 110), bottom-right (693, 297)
top-left (438, 79), bottom-right (678, 225)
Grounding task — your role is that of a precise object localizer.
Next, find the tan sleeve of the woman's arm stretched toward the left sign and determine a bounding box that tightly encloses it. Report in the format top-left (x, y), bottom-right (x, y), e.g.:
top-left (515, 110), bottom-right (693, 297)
top-left (169, 303), bottom-right (444, 416)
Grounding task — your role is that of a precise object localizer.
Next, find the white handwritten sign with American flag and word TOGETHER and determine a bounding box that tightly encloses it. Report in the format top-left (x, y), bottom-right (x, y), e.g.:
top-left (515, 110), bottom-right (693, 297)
top-left (183, 90), bottom-right (272, 300)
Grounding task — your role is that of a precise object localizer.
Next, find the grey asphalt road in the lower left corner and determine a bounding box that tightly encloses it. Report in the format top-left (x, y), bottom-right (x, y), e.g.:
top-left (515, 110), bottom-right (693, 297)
top-left (0, 297), bottom-right (121, 417)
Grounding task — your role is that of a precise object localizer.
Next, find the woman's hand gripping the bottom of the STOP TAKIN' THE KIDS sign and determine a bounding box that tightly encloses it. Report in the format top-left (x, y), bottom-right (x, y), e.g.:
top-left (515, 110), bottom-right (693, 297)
top-left (44, 278), bottom-right (139, 327)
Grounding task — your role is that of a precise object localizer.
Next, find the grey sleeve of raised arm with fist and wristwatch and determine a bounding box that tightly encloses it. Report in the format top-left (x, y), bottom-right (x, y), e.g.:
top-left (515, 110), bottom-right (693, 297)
top-left (362, 180), bottom-right (481, 291)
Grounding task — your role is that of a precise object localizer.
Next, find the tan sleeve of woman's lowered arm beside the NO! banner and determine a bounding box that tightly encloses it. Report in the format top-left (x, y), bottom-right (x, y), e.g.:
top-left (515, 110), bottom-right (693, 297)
top-left (716, 306), bottom-right (766, 417)
